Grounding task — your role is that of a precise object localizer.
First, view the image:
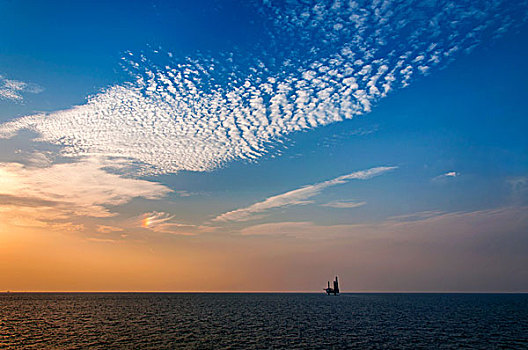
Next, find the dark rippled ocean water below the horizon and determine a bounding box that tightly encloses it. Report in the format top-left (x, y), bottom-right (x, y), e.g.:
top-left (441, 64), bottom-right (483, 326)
top-left (0, 293), bottom-right (528, 349)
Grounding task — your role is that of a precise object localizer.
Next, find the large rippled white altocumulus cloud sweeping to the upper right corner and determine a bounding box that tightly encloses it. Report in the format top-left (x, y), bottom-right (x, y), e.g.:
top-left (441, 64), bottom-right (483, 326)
top-left (0, 0), bottom-right (528, 175)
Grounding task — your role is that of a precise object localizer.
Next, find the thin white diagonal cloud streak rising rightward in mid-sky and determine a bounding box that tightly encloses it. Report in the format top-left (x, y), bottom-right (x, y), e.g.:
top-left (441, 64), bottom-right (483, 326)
top-left (214, 167), bottom-right (396, 221)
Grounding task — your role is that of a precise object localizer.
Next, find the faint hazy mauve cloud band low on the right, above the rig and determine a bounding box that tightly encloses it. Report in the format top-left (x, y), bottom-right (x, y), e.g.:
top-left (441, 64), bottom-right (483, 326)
top-left (240, 206), bottom-right (528, 241)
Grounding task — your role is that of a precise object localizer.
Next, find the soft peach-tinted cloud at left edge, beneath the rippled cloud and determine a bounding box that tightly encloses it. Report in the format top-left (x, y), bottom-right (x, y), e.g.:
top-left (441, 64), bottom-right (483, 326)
top-left (0, 158), bottom-right (171, 223)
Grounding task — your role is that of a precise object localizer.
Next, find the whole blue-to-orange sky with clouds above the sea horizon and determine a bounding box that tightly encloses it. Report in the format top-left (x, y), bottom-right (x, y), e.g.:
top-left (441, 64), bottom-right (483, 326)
top-left (0, 0), bottom-right (528, 292)
